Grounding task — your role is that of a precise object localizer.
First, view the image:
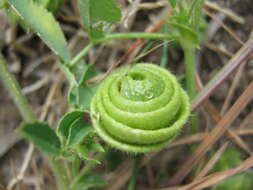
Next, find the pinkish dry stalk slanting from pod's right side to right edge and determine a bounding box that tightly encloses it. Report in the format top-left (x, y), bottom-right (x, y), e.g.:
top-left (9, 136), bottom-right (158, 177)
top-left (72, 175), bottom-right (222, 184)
top-left (192, 35), bottom-right (253, 111)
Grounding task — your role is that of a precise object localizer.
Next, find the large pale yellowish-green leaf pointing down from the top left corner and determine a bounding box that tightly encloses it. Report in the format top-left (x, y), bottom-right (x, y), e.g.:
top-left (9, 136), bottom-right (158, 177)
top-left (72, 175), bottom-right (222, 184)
top-left (8, 0), bottom-right (71, 62)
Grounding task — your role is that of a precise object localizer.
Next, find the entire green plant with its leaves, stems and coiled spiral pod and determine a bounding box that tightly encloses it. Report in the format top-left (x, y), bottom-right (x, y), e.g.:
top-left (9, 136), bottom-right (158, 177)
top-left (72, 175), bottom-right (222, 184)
top-left (0, 0), bottom-right (208, 190)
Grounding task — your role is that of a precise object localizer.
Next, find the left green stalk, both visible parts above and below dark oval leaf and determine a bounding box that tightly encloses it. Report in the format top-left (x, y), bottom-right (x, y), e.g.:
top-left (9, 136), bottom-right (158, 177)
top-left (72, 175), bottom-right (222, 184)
top-left (0, 54), bottom-right (68, 190)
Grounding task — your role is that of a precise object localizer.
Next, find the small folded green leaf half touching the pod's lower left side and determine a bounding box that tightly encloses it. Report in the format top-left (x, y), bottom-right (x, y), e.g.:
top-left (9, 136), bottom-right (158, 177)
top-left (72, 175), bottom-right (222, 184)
top-left (67, 117), bottom-right (93, 147)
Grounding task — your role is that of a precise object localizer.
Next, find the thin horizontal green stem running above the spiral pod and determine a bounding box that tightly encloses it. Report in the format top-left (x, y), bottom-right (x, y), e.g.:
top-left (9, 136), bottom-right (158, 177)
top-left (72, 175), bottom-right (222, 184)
top-left (94, 32), bottom-right (176, 44)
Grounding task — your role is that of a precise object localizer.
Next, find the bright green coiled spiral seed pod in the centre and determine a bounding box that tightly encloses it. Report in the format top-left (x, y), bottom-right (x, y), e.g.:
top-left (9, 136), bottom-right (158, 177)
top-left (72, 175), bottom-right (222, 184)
top-left (91, 63), bottom-right (190, 153)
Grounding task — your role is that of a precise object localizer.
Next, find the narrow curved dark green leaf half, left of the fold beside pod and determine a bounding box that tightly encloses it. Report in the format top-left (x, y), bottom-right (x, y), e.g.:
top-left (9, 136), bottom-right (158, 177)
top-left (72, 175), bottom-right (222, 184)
top-left (57, 110), bottom-right (84, 141)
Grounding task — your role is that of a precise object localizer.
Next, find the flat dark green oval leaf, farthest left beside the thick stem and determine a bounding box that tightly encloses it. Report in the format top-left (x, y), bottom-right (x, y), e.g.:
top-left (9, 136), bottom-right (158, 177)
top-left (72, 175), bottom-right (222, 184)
top-left (19, 122), bottom-right (61, 156)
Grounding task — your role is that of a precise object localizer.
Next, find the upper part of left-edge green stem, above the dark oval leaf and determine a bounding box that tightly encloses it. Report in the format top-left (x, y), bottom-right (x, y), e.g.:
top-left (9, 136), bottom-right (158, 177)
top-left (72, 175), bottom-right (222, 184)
top-left (0, 54), bottom-right (36, 122)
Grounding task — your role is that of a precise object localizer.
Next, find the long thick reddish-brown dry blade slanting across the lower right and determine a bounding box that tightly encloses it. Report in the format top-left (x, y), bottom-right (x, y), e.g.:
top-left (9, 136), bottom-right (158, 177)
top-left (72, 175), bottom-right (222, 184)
top-left (169, 82), bottom-right (253, 185)
